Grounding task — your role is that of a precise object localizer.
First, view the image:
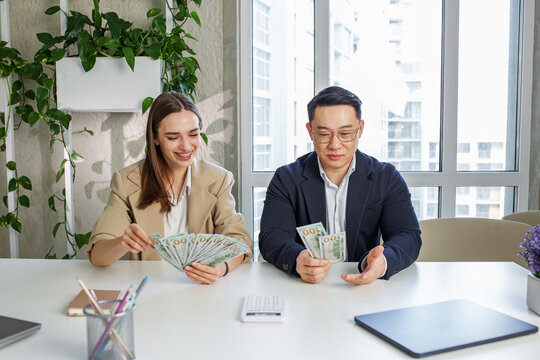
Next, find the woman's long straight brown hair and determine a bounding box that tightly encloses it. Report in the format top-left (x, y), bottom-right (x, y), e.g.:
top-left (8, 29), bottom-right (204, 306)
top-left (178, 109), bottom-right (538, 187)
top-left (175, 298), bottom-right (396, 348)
top-left (137, 91), bottom-right (202, 212)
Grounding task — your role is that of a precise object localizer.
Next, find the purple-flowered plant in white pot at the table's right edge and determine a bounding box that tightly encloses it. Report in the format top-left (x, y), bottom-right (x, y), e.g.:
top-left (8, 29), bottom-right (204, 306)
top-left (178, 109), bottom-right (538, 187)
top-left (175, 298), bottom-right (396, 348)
top-left (519, 224), bottom-right (540, 315)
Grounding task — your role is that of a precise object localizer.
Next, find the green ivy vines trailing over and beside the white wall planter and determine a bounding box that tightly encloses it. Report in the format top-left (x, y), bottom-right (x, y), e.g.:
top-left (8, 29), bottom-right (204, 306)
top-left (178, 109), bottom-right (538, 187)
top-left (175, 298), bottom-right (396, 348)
top-left (0, 0), bottom-right (202, 258)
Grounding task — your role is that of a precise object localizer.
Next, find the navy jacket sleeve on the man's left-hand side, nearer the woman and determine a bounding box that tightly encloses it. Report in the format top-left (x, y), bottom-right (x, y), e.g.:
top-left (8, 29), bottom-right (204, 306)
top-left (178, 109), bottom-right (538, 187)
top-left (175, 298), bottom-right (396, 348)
top-left (259, 169), bottom-right (305, 275)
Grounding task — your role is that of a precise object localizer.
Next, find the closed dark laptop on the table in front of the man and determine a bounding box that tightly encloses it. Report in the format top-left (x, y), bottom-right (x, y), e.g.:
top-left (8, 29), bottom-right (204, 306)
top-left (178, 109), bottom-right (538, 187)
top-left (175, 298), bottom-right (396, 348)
top-left (354, 300), bottom-right (538, 358)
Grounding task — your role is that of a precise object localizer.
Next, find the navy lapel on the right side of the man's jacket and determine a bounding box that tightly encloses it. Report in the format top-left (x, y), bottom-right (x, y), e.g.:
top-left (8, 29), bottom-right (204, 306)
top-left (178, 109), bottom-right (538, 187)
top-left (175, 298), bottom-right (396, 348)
top-left (345, 150), bottom-right (373, 257)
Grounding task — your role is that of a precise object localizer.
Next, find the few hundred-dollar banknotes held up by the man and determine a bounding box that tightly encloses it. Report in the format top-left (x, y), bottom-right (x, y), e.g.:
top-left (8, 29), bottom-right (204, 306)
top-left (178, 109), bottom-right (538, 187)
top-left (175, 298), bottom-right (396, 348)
top-left (296, 222), bottom-right (346, 263)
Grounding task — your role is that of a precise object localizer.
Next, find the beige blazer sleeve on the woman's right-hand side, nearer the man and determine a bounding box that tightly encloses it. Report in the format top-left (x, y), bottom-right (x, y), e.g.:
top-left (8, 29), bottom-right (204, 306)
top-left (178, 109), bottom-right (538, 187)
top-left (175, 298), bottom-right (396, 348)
top-left (212, 171), bottom-right (253, 263)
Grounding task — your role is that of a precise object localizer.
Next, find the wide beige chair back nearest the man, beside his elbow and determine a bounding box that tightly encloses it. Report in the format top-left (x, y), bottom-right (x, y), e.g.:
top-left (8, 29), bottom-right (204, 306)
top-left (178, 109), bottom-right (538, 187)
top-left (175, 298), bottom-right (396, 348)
top-left (418, 218), bottom-right (531, 267)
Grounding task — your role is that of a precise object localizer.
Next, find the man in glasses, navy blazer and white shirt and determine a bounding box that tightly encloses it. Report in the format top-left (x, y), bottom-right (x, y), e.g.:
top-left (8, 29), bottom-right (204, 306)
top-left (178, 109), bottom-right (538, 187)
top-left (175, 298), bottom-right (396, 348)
top-left (259, 86), bottom-right (422, 284)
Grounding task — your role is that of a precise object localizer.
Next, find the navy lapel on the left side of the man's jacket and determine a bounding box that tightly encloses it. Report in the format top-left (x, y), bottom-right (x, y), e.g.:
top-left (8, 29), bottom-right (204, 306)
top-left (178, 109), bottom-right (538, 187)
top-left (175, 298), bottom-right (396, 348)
top-left (300, 152), bottom-right (326, 227)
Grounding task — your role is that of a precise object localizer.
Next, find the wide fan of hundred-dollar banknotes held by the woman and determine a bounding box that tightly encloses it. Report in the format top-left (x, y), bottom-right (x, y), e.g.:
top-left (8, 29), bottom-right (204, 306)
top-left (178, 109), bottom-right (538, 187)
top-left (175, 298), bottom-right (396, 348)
top-left (149, 233), bottom-right (251, 271)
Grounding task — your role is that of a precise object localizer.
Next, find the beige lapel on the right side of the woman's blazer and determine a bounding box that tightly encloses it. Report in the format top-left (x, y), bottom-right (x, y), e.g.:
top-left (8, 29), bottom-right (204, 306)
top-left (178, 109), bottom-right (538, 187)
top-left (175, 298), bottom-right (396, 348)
top-left (188, 160), bottom-right (217, 233)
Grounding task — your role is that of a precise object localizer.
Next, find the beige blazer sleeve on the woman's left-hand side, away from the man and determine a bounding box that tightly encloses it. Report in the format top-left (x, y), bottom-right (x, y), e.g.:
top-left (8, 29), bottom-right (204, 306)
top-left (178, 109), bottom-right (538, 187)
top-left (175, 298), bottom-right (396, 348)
top-left (86, 172), bottom-right (133, 258)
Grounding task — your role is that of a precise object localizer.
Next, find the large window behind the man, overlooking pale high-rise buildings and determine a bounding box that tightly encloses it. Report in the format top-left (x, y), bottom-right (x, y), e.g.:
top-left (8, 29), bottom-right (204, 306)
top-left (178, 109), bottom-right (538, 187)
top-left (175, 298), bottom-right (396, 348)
top-left (240, 0), bottom-right (534, 258)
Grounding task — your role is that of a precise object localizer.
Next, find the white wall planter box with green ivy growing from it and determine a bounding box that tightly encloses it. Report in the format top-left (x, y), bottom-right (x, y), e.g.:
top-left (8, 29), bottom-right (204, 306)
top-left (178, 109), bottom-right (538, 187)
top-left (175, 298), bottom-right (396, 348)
top-left (36, 0), bottom-right (200, 111)
